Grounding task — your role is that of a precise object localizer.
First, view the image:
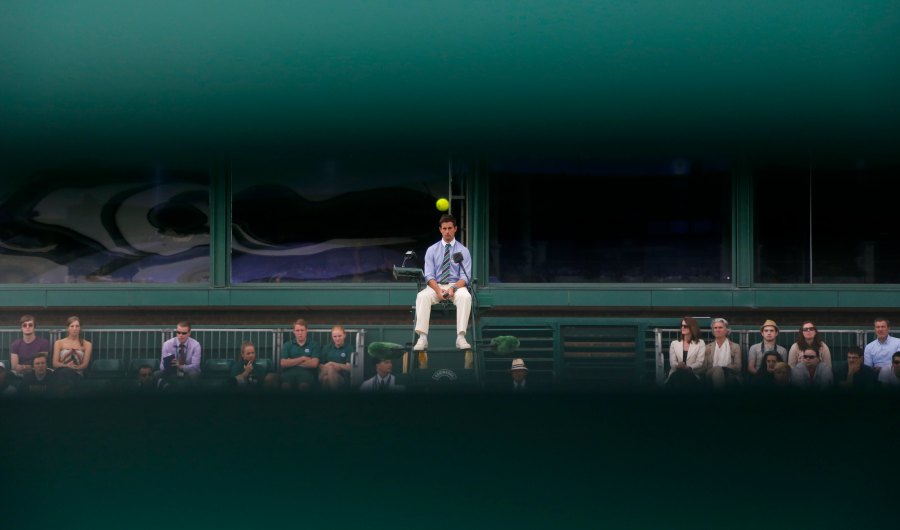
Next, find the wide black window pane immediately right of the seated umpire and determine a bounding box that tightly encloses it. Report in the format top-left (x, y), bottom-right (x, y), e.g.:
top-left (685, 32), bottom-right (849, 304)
top-left (490, 156), bottom-right (732, 283)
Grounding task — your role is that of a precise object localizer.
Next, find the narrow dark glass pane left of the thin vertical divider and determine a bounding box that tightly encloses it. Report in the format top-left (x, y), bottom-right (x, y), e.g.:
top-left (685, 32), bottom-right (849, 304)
top-left (753, 166), bottom-right (809, 283)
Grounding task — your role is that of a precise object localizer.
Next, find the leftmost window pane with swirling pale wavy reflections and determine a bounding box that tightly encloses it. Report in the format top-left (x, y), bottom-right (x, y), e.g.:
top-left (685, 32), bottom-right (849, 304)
top-left (0, 166), bottom-right (210, 284)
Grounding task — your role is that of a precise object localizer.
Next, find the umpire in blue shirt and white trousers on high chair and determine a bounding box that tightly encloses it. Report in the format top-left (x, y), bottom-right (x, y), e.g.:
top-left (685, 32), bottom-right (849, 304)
top-left (413, 210), bottom-right (472, 351)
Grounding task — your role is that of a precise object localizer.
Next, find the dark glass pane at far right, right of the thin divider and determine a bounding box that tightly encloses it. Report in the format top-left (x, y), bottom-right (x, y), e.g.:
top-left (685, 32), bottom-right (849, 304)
top-left (812, 168), bottom-right (900, 283)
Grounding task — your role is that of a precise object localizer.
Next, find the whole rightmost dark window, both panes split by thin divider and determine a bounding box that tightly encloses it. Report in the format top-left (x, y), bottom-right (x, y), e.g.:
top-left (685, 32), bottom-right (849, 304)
top-left (754, 165), bottom-right (900, 283)
